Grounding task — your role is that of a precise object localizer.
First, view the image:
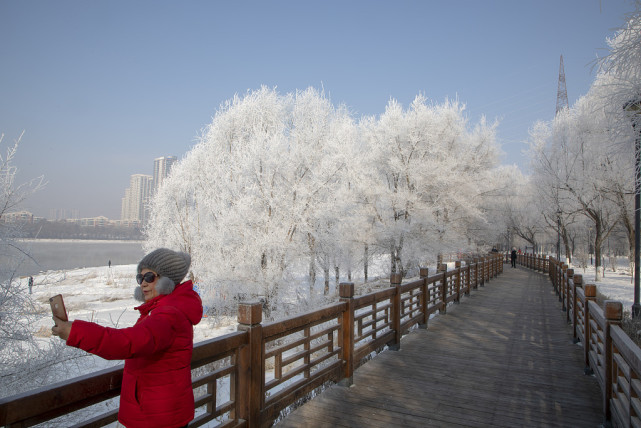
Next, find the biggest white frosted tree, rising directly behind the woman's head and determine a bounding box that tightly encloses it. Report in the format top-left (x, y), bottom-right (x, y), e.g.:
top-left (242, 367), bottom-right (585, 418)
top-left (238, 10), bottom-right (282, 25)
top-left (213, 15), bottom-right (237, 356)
top-left (147, 87), bottom-right (352, 314)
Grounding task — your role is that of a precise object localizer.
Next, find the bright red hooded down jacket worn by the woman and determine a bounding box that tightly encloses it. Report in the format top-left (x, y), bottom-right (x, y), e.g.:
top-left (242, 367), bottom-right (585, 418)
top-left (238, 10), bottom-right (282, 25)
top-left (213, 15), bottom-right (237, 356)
top-left (67, 281), bottom-right (203, 428)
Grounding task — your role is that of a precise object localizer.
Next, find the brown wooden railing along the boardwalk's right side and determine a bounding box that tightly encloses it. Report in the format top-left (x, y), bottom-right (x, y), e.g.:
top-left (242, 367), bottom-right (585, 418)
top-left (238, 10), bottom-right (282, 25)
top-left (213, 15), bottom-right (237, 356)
top-left (518, 252), bottom-right (641, 427)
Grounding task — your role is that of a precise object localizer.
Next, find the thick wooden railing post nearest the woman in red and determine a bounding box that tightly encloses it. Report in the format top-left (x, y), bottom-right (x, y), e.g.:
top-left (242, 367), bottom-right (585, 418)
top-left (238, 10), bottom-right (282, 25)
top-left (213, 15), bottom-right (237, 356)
top-left (238, 302), bottom-right (264, 428)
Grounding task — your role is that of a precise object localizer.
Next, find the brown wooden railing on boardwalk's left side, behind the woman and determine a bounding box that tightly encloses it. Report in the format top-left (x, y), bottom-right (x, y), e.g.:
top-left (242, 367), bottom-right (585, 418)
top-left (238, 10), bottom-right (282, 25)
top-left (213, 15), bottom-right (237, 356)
top-left (0, 254), bottom-right (503, 427)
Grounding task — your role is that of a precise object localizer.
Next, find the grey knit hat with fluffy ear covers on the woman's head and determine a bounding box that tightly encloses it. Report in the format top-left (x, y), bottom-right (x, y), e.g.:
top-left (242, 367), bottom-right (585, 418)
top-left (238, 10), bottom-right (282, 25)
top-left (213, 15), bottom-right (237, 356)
top-left (134, 248), bottom-right (191, 301)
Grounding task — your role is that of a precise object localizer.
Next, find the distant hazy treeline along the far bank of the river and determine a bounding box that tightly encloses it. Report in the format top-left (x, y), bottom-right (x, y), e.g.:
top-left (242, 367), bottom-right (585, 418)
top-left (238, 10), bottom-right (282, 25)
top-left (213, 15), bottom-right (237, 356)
top-left (20, 220), bottom-right (143, 240)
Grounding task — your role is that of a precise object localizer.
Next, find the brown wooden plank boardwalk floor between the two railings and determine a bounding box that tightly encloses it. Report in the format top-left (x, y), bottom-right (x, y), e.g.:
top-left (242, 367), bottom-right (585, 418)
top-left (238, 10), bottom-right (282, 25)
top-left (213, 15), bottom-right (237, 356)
top-left (277, 265), bottom-right (603, 428)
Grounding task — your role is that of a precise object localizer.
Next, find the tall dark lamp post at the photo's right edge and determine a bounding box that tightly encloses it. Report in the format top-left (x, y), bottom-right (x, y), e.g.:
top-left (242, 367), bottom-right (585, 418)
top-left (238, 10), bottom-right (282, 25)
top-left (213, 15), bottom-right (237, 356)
top-left (623, 97), bottom-right (641, 318)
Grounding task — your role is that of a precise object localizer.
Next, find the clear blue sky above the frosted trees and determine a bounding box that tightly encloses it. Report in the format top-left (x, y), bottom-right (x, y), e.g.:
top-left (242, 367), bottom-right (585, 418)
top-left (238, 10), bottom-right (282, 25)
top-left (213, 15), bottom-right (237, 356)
top-left (0, 0), bottom-right (634, 219)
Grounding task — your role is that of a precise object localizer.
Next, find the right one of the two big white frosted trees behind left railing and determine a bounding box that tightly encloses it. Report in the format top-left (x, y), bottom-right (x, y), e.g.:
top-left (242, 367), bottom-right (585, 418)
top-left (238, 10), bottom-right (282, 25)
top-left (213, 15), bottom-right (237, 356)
top-left (363, 95), bottom-right (498, 273)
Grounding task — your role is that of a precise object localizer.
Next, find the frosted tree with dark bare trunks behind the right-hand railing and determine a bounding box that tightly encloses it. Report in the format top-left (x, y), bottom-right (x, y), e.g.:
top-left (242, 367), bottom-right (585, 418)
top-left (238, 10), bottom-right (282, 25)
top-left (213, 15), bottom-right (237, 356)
top-left (531, 82), bottom-right (634, 279)
